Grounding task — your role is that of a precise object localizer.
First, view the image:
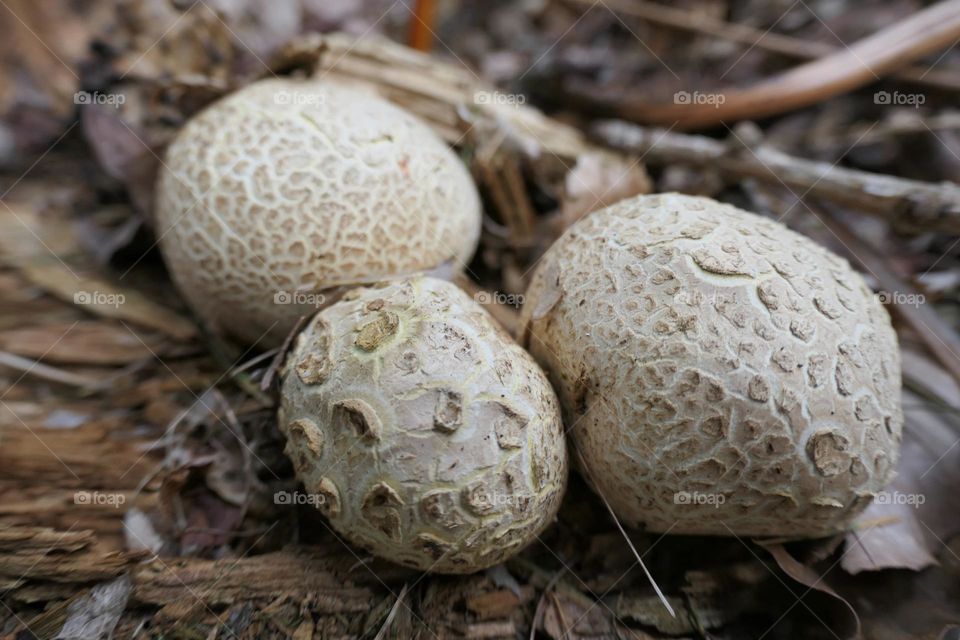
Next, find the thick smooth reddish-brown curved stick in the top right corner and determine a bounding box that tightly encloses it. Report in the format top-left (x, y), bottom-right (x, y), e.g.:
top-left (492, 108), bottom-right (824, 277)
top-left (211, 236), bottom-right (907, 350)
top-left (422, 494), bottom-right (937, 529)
top-left (585, 0), bottom-right (960, 128)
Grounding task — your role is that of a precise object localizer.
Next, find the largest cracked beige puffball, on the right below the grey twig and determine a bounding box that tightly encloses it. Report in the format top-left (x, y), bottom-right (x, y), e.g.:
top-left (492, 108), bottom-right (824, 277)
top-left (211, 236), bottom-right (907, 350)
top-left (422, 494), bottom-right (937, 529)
top-left (522, 194), bottom-right (903, 537)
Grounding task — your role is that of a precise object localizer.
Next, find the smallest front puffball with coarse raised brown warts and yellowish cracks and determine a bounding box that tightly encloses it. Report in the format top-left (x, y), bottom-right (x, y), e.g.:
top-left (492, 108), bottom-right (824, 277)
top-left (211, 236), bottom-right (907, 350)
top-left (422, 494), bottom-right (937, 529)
top-left (279, 277), bottom-right (567, 573)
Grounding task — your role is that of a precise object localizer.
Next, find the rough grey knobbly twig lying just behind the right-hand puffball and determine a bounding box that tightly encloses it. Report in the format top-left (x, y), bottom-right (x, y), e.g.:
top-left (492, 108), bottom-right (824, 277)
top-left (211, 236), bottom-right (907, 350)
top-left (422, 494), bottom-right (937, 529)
top-left (594, 121), bottom-right (960, 234)
